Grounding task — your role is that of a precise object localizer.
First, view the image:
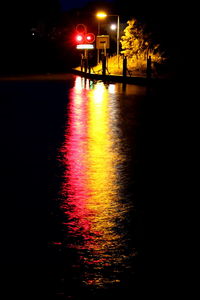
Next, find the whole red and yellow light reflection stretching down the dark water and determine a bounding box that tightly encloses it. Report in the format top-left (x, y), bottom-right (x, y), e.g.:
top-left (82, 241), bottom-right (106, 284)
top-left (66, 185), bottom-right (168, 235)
top-left (57, 77), bottom-right (135, 287)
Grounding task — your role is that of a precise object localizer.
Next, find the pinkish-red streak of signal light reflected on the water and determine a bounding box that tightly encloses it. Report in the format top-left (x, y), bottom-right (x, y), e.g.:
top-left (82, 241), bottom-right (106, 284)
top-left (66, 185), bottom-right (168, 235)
top-left (61, 77), bottom-right (89, 239)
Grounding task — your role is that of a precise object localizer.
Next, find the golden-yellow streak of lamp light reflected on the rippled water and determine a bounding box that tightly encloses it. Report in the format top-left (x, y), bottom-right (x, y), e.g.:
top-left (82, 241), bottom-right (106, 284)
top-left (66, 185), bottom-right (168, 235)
top-left (85, 83), bottom-right (127, 285)
